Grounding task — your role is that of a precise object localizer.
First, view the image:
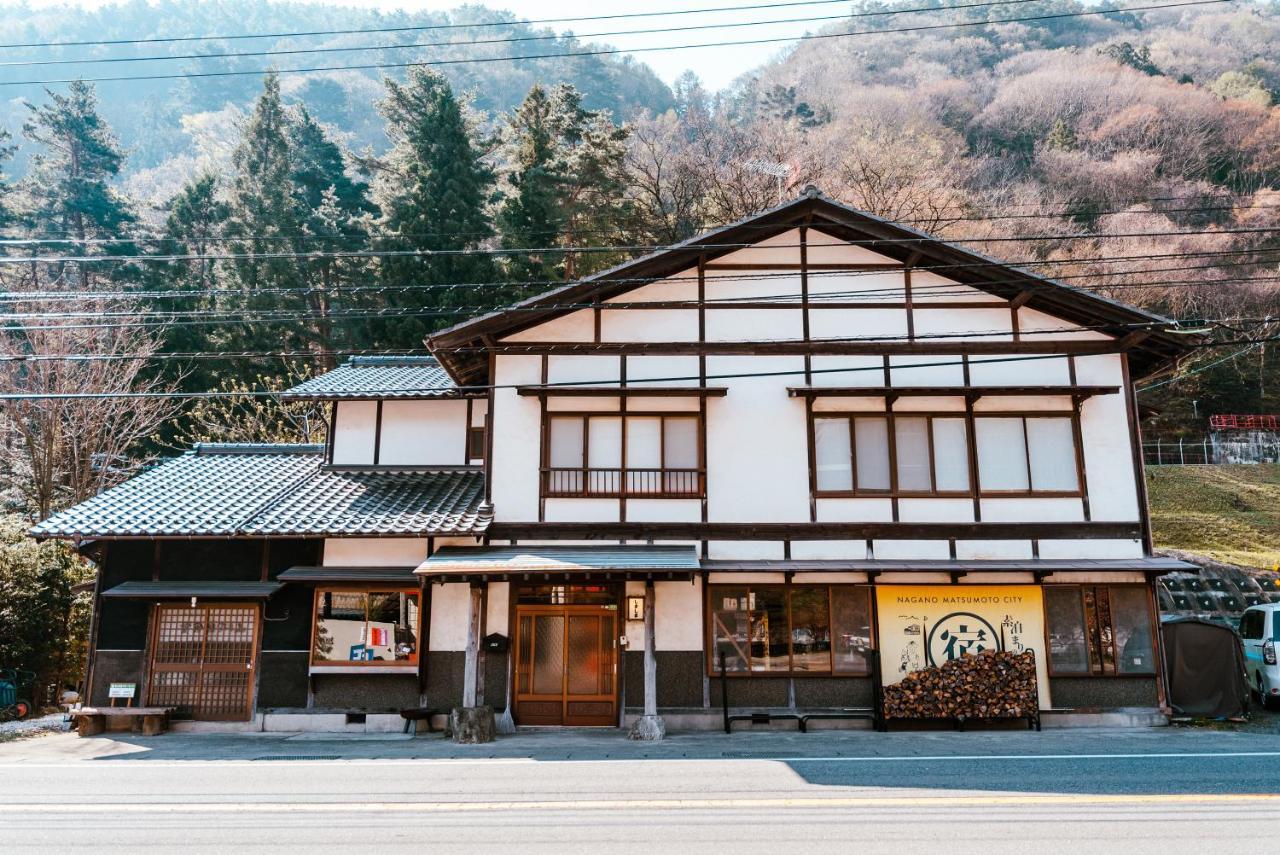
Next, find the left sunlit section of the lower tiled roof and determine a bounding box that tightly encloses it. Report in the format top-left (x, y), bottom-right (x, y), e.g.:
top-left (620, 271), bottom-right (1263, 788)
top-left (31, 444), bottom-right (324, 538)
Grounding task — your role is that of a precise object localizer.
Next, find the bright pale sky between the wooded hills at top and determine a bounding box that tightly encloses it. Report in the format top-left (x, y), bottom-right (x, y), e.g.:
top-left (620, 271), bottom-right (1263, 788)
top-left (17, 0), bottom-right (829, 90)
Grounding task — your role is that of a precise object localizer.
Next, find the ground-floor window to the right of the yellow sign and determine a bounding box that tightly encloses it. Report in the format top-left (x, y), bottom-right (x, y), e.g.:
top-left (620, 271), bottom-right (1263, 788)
top-left (1044, 585), bottom-right (1156, 676)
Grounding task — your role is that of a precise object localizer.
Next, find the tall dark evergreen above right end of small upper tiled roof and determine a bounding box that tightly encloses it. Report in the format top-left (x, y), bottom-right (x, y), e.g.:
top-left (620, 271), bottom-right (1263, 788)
top-left (375, 68), bottom-right (499, 348)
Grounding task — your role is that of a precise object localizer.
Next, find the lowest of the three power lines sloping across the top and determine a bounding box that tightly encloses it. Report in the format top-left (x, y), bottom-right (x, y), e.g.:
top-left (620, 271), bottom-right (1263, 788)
top-left (0, 0), bottom-right (1233, 86)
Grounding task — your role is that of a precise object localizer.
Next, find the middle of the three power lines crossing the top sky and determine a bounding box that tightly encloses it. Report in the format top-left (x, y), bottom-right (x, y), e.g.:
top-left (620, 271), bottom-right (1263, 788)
top-left (0, 0), bottom-right (1041, 68)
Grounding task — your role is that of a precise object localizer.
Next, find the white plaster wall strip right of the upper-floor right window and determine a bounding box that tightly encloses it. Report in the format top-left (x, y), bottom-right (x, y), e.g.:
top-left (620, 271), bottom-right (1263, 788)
top-left (1075, 355), bottom-right (1139, 521)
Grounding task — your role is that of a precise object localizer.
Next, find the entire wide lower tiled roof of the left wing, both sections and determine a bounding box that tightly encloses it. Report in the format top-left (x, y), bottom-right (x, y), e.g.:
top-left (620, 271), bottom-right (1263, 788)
top-left (31, 444), bottom-right (492, 538)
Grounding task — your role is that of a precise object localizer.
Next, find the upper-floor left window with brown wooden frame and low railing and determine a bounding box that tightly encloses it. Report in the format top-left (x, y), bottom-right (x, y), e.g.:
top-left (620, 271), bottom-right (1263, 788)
top-left (538, 410), bottom-right (707, 499)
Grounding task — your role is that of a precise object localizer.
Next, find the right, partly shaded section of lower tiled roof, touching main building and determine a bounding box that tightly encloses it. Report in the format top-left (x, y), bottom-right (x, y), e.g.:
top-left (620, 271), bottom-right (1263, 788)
top-left (244, 470), bottom-right (492, 535)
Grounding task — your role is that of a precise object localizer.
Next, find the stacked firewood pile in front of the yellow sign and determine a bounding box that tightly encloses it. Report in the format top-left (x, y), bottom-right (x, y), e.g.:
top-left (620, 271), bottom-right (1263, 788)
top-left (884, 650), bottom-right (1039, 718)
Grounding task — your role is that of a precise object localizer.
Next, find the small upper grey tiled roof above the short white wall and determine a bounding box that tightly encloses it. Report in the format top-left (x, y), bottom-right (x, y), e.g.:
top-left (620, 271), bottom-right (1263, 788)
top-left (280, 356), bottom-right (467, 401)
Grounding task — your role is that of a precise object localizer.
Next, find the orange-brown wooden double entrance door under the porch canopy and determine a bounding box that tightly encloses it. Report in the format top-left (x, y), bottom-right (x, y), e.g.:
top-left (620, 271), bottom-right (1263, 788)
top-left (515, 605), bottom-right (618, 727)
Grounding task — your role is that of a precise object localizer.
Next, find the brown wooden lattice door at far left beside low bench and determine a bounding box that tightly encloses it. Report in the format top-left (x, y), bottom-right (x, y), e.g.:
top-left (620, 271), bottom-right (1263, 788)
top-left (147, 603), bottom-right (257, 722)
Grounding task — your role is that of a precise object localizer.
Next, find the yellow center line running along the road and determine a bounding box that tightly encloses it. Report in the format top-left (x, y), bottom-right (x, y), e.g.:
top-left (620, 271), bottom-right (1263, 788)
top-left (0, 792), bottom-right (1280, 815)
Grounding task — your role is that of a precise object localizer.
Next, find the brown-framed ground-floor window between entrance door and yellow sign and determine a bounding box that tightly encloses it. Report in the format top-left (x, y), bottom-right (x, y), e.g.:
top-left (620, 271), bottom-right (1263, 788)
top-left (708, 585), bottom-right (872, 675)
